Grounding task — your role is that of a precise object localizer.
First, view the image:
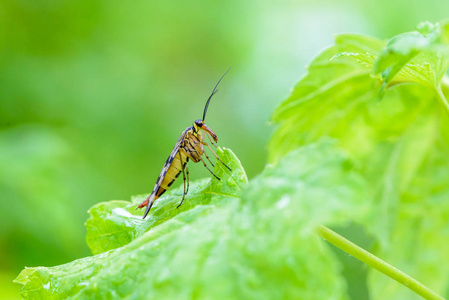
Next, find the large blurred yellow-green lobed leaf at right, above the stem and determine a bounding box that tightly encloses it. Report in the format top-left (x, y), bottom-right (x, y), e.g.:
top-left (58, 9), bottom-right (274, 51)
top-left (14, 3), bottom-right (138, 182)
top-left (269, 35), bottom-right (446, 243)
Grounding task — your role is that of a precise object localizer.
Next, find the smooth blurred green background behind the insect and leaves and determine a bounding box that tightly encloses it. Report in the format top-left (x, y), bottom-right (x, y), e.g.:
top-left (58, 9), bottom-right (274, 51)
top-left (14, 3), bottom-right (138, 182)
top-left (0, 0), bottom-right (449, 299)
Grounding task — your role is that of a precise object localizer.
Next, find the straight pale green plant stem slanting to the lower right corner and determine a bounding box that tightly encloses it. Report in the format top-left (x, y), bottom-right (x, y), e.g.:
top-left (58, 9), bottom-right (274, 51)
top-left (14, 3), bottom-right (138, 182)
top-left (318, 226), bottom-right (444, 300)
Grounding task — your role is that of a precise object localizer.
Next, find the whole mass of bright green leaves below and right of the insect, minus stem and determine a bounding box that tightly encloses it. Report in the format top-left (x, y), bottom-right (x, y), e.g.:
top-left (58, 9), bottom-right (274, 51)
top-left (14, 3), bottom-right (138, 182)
top-left (12, 23), bottom-right (449, 299)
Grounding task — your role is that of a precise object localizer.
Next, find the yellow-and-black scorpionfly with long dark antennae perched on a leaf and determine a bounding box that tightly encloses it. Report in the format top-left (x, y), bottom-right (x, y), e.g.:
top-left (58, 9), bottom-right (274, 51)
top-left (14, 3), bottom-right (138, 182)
top-left (136, 69), bottom-right (232, 219)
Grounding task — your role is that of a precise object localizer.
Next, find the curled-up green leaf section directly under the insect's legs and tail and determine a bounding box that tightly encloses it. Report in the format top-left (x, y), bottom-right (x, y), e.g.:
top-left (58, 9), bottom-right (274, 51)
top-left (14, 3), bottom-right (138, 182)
top-left (86, 148), bottom-right (248, 254)
